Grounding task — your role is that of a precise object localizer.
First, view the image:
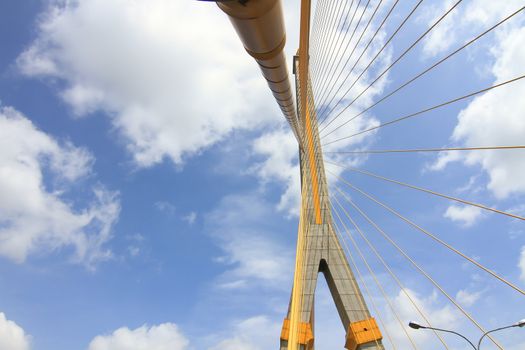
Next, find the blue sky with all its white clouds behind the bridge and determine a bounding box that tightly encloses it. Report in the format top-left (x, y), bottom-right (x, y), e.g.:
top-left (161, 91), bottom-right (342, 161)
top-left (0, 0), bottom-right (525, 350)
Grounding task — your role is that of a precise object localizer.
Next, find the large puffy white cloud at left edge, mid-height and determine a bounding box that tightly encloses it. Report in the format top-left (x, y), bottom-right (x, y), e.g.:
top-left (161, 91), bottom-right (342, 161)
top-left (0, 107), bottom-right (120, 265)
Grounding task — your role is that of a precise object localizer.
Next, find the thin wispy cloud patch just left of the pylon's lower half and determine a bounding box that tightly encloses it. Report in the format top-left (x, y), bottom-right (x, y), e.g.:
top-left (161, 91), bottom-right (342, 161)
top-left (205, 195), bottom-right (293, 288)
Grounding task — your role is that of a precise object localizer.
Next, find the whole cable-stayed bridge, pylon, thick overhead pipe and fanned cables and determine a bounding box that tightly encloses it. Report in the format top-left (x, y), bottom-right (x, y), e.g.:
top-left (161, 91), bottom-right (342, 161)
top-left (211, 0), bottom-right (525, 350)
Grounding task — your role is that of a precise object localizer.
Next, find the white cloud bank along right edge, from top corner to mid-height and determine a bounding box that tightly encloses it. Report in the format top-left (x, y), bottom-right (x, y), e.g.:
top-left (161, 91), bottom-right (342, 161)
top-left (427, 0), bottom-right (525, 199)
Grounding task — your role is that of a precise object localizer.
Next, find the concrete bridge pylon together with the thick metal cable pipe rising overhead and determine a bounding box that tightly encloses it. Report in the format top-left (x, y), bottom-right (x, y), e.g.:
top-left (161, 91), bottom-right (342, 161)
top-left (213, 0), bottom-right (384, 350)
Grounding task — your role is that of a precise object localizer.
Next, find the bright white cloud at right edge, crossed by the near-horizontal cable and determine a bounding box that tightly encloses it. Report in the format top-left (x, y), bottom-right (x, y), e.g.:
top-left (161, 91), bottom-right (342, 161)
top-left (433, 20), bottom-right (525, 199)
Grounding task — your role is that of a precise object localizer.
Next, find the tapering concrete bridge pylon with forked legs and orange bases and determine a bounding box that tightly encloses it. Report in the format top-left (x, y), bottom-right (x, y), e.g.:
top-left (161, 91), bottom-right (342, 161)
top-left (280, 49), bottom-right (384, 350)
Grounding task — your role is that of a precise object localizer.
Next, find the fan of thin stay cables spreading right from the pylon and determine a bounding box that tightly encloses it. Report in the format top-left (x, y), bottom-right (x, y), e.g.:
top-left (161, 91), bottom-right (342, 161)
top-left (308, 0), bottom-right (525, 349)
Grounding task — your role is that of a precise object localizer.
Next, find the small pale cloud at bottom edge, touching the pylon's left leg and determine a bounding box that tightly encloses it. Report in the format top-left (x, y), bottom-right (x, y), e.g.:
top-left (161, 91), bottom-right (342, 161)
top-left (209, 316), bottom-right (281, 350)
